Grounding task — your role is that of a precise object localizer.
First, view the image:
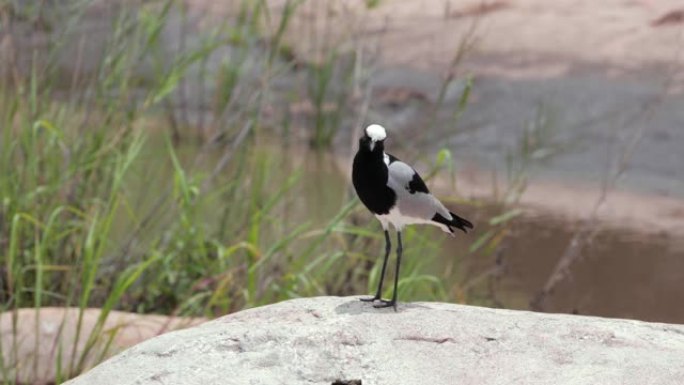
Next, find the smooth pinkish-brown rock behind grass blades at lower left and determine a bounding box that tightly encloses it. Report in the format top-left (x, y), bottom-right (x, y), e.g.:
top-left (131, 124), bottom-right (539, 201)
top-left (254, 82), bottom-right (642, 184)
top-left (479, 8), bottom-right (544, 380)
top-left (0, 307), bottom-right (206, 384)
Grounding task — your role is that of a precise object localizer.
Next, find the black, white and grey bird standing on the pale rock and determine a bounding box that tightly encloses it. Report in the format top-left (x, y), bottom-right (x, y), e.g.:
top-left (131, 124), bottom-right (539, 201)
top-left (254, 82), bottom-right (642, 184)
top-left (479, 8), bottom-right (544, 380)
top-left (352, 124), bottom-right (473, 310)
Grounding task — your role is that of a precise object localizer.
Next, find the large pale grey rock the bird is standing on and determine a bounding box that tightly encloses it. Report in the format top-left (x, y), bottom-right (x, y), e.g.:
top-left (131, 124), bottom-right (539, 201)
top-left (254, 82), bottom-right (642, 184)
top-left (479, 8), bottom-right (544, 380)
top-left (67, 297), bottom-right (684, 385)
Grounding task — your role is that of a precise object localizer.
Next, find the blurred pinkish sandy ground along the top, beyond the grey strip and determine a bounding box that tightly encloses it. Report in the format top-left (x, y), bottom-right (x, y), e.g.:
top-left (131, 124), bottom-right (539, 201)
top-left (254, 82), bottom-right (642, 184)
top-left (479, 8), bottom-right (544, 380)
top-left (260, 0), bottom-right (684, 74)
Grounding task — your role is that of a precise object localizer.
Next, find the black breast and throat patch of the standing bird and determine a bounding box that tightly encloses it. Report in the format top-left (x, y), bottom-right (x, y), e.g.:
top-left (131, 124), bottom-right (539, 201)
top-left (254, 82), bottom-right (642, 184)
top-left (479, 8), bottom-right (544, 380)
top-left (352, 151), bottom-right (397, 214)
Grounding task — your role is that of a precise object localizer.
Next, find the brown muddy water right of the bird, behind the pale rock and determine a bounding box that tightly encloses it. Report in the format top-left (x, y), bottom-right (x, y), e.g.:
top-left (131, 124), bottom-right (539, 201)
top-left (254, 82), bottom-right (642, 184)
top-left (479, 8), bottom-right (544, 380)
top-left (445, 210), bottom-right (684, 323)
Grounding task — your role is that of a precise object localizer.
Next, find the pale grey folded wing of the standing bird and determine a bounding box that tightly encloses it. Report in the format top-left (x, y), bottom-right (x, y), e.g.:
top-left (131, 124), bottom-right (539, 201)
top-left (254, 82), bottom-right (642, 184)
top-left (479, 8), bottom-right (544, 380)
top-left (387, 155), bottom-right (451, 220)
